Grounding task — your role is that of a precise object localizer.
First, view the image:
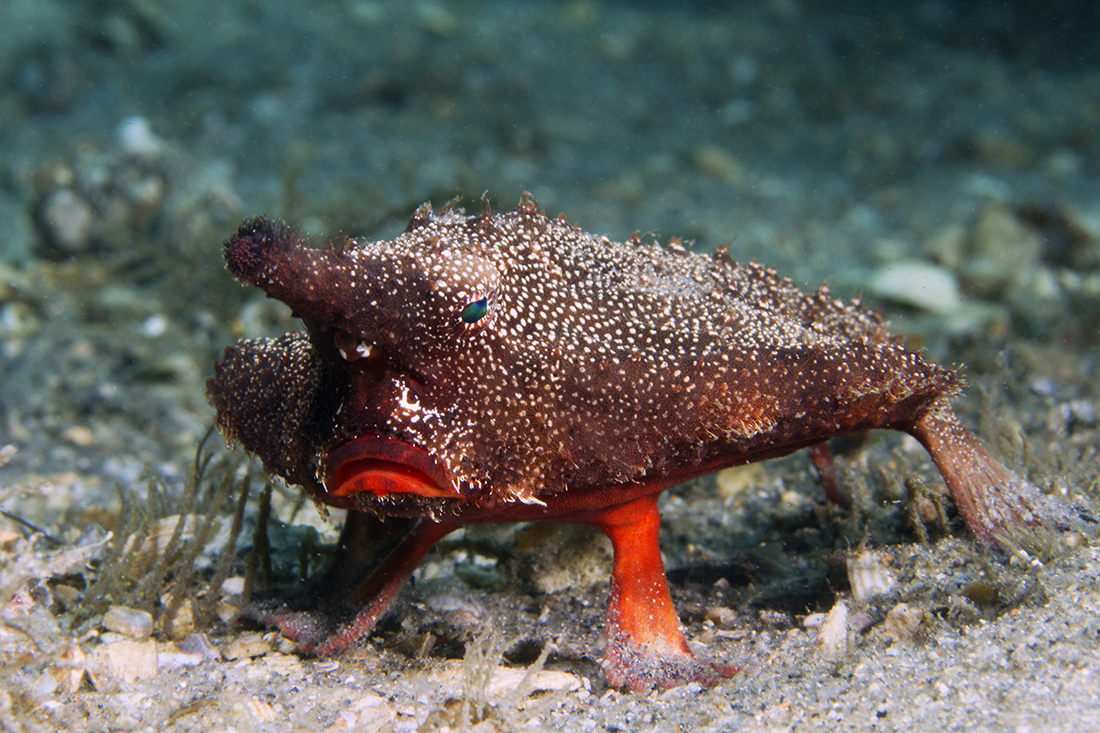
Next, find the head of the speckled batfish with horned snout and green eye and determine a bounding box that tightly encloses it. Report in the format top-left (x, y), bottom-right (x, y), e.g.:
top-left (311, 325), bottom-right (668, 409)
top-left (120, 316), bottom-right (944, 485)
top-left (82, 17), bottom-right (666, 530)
top-left (208, 197), bottom-right (567, 514)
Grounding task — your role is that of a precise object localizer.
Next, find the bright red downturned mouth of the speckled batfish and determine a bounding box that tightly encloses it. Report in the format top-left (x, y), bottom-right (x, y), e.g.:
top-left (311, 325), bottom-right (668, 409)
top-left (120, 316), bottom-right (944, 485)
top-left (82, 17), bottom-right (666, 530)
top-left (325, 435), bottom-right (462, 499)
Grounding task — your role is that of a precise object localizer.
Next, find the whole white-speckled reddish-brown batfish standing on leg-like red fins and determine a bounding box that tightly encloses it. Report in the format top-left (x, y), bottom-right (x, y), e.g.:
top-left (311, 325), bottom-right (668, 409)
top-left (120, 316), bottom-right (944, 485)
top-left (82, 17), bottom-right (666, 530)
top-left (208, 197), bottom-right (1065, 689)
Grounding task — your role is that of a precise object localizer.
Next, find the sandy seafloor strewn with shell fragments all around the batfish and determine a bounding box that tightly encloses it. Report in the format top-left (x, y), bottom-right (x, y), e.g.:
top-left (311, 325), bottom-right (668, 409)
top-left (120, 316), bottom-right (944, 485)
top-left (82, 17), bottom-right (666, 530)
top-left (0, 0), bottom-right (1100, 733)
